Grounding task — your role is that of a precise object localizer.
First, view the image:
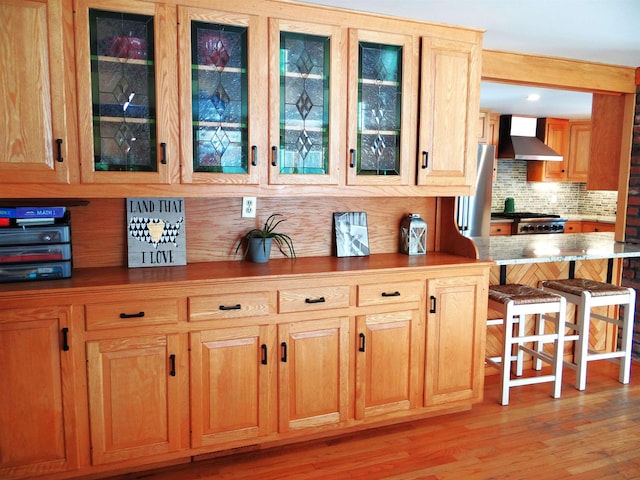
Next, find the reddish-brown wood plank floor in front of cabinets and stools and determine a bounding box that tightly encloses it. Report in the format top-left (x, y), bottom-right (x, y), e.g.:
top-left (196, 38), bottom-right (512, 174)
top-left (104, 361), bottom-right (640, 480)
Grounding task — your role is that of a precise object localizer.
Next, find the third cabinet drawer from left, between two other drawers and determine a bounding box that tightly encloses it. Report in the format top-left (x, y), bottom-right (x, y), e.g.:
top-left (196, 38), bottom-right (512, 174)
top-left (278, 285), bottom-right (349, 313)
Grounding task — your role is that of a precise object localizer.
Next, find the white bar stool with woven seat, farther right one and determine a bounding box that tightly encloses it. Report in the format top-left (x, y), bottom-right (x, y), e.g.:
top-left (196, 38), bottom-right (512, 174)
top-left (541, 278), bottom-right (636, 390)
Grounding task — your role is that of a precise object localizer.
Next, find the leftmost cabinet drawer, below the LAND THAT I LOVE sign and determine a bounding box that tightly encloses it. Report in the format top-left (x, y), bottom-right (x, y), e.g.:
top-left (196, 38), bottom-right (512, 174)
top-left (85, 298), bottom-right (180, 330)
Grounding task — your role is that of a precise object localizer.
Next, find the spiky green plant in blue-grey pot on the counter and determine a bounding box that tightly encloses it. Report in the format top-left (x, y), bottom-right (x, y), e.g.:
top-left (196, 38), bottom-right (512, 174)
top-left (236, 213), bottom-right (296, 263)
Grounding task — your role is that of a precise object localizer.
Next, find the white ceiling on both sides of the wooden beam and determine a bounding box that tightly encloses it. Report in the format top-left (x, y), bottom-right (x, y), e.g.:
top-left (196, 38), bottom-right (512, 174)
top-left (292, 0), bottom-right (640, 118)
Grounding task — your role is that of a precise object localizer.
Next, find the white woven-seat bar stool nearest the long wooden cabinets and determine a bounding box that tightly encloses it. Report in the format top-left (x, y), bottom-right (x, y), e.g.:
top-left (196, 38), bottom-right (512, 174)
top-left (486, 284), bottom-right (566, 405)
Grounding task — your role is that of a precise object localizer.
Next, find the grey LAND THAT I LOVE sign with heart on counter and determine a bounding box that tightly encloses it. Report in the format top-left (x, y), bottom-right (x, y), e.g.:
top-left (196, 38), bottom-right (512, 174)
top-left (126, 198), bottom-right (187, 267)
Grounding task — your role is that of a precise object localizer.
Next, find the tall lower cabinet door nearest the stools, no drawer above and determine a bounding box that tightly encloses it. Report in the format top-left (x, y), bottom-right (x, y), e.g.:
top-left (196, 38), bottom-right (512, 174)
top-left (424, 275), bottom-right (488, 406)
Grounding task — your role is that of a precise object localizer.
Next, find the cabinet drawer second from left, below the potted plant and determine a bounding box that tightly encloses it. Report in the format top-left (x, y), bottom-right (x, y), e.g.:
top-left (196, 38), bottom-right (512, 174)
top-left (189, 292), bottom-right (271, 322)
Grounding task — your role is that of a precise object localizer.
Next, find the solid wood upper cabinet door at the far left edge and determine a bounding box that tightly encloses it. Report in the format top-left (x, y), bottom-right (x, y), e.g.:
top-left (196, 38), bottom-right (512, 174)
top-left (0, 0), bottom-right (78, 184)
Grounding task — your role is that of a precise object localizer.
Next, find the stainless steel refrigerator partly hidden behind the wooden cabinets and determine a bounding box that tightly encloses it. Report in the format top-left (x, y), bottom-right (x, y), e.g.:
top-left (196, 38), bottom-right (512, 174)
top-left (456, 143), bottom-right (496, 237)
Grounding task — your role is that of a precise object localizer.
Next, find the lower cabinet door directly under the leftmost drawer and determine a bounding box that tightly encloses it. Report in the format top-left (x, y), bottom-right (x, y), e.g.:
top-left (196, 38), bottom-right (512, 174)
top-left (87, 334), bottom-right (189, 464)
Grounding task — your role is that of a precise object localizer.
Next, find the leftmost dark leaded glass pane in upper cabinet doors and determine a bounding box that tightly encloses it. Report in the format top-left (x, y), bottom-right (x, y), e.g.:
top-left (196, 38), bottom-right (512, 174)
top-left (89, 9), bottom-right (158, 172)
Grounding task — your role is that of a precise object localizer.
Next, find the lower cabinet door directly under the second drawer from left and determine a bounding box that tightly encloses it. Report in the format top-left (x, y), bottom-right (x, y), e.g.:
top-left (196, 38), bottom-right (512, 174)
top-left (189, 325), bottom-right (276, 448)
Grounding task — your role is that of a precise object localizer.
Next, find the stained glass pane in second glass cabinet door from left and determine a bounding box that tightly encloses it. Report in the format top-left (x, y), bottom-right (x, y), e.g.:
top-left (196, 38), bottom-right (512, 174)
top-left (191, 22), bottom-right (249, 173)
